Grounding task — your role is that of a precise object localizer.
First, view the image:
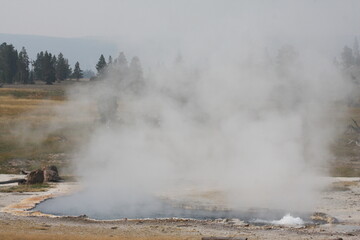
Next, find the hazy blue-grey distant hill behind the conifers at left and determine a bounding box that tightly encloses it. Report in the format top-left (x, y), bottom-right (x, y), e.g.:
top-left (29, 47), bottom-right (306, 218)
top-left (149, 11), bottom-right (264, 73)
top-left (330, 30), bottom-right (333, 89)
top-left (0, 33), bottom-right (118, 70)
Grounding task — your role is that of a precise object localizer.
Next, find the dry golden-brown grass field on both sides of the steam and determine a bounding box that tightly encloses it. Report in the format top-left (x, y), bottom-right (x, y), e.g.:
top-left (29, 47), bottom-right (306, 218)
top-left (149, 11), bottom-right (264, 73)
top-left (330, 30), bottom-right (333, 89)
top-left (0, 83), bottom-right (360, 177)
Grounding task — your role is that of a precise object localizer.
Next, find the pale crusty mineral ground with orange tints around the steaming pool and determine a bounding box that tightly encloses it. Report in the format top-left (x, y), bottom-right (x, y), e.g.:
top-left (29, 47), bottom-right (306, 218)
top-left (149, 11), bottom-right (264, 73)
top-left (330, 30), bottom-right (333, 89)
top-left (0, 174), bottom-right (360, 240)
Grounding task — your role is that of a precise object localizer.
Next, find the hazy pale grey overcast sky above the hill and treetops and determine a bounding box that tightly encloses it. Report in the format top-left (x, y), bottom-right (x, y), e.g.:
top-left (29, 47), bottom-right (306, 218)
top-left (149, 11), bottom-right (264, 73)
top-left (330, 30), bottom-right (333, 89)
top-left (0, 0), bottom-right (360, 62)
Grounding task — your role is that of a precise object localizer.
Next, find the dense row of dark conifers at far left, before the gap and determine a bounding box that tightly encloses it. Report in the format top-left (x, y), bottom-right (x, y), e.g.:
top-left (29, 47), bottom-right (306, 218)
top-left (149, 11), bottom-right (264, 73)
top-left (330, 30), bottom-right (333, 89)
top-left (0, 42), bottom-right (83, 84)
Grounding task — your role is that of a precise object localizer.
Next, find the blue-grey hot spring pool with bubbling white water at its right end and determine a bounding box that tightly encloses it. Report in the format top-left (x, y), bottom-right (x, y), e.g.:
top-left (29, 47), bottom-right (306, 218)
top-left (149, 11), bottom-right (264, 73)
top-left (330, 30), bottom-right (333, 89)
top-left (33, 193), bottom-right (311, 225)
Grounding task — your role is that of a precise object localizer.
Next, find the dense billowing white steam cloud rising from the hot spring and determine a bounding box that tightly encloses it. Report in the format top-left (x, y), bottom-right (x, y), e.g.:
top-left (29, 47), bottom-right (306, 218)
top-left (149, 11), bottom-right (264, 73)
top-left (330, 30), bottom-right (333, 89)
top-left (27, 0), bottom-right (354, 217)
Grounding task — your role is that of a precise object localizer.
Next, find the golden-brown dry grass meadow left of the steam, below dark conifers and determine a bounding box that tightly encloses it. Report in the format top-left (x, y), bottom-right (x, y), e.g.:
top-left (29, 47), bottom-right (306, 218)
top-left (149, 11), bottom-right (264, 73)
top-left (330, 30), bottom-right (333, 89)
top-left (0, 85), bottom-right (94, 173)
